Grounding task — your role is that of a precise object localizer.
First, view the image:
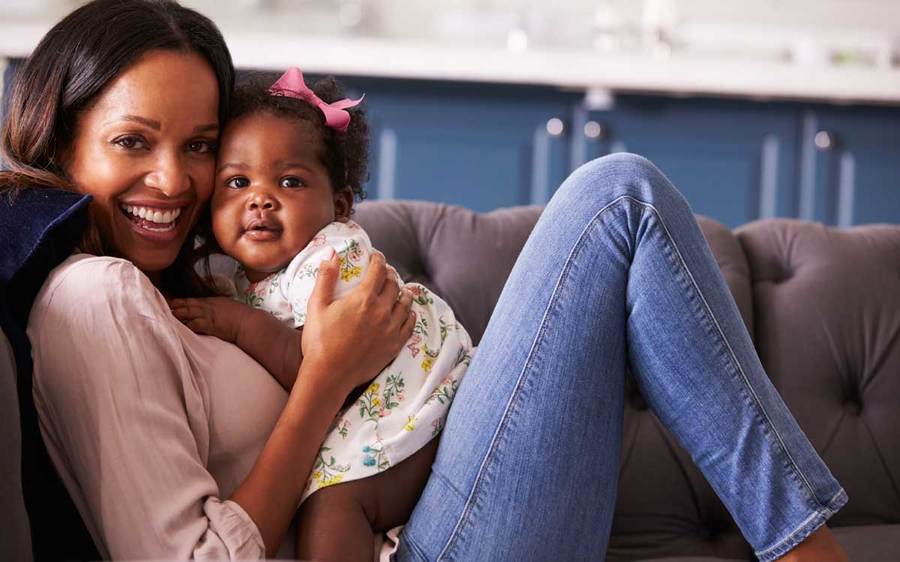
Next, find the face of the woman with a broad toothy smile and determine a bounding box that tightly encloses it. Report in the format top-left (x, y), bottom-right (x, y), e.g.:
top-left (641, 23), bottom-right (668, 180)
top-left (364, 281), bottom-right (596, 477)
top-left (64, 51), bottom-right (219, 273)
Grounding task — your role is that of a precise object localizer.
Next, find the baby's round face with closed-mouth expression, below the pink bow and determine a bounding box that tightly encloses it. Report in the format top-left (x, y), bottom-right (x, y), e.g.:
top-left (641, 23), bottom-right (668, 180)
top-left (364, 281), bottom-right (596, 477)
top-left (211, 112), bottom-right (352, 281)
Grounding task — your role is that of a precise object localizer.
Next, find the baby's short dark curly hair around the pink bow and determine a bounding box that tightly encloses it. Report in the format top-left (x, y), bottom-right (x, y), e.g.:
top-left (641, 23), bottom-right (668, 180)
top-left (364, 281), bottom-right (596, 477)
top-left (228, 72), bottom-right (369, 206)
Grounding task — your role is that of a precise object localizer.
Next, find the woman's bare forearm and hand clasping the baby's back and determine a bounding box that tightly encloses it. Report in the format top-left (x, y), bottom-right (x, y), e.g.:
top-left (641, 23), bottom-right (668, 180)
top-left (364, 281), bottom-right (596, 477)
top-left (232, 250), bottom-right (415, 556)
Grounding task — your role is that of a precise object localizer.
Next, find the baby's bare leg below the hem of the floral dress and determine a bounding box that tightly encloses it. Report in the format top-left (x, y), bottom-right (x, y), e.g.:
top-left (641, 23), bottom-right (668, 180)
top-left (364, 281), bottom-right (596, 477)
top-left (297, 439), bottom-right (438, 562)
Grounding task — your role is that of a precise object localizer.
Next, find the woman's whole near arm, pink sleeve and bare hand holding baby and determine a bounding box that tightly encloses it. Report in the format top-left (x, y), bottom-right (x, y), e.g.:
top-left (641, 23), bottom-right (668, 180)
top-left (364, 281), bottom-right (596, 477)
top-left (29, 253), bottom-right (412, 559)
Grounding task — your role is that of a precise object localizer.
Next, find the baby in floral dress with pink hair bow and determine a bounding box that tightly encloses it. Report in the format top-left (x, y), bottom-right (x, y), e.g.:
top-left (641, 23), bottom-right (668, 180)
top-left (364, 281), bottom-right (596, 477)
top-left (172, 68), bottom-right (473, 560)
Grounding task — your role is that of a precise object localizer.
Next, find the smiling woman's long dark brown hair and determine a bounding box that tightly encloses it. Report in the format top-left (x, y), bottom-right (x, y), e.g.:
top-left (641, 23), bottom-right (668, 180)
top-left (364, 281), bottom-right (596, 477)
top-left (0, 0), bottom-right (234, 294)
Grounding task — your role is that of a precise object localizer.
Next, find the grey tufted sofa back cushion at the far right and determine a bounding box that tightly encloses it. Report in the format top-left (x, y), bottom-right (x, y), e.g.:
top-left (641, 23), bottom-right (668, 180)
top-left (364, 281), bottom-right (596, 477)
top-left (736, 220), bottom-right (900, 528)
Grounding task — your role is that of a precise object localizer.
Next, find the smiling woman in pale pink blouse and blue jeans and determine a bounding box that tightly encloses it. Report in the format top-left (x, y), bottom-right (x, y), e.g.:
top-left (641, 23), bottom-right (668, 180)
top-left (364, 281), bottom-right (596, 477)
top-left (2, 0), bottom-right (846, 561)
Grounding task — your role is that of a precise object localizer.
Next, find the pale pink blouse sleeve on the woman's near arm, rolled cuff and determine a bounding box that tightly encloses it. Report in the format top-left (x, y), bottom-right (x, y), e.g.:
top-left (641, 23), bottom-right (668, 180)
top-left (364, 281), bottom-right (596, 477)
top-left (28, 257), bottom-right (265, 560)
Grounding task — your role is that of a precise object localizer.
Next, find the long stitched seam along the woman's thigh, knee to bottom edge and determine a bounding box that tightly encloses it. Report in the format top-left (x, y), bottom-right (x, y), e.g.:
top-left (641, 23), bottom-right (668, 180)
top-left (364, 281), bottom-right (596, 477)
top-left (437, 196), bottom-right (630, 560)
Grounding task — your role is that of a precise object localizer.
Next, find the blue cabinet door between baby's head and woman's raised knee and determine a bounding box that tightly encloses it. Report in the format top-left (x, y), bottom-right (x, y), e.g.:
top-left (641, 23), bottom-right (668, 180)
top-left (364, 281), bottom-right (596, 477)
top-left (344, 80), bottom-right (577, 211)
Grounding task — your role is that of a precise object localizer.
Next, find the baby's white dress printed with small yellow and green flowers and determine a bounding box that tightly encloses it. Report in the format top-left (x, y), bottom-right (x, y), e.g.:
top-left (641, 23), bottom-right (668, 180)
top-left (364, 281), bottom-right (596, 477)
top-left (234, 221), bottom-right (473, 503)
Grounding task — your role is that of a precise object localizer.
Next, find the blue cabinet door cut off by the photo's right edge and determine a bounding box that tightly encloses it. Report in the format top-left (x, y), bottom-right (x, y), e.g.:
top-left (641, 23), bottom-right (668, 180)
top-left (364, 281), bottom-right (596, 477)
top-left (799, 107), bottom-right (900, 226)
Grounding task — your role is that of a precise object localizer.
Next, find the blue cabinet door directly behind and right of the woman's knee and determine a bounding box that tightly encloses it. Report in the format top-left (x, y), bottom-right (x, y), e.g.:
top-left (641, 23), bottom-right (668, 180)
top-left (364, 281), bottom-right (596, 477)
top-left (573, 96), bottom-right (798, 227)
